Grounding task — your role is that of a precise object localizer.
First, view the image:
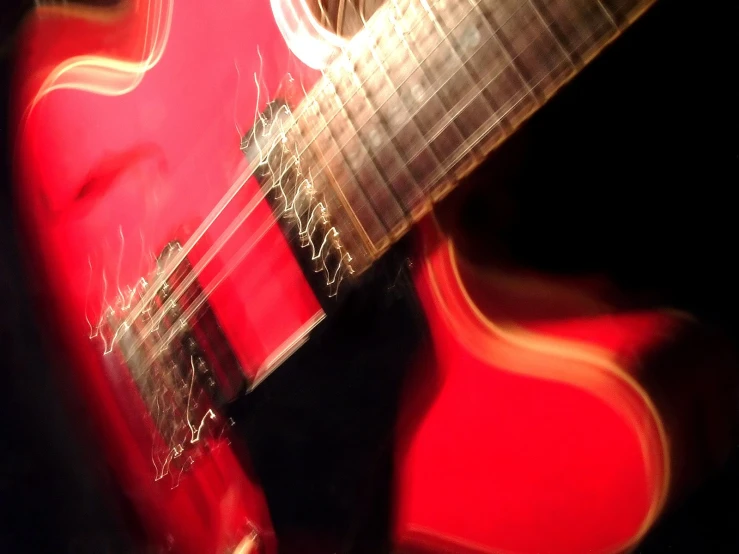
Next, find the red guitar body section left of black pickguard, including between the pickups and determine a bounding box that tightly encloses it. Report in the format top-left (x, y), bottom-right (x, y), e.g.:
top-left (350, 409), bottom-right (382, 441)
top-left (13, 0), bottom-right (320, 554)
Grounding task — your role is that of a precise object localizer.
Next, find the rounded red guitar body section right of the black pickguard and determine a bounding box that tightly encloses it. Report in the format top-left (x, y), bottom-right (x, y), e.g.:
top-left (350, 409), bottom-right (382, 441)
top-left (395, 221), bottom-right (679, 554)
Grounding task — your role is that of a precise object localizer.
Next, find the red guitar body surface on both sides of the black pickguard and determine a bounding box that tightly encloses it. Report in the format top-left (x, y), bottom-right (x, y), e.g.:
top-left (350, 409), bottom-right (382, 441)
top-left (13, 0), bottom-right (736, 554)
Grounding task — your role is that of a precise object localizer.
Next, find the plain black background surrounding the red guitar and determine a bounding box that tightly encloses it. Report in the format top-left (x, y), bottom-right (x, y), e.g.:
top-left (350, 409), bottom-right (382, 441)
top-left (0, 0), bottom-right (739, 553)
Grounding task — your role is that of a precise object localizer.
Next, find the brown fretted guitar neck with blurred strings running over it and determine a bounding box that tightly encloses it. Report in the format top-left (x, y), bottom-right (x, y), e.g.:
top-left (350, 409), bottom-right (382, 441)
top-left (274, 0), bottom-right (652, 273)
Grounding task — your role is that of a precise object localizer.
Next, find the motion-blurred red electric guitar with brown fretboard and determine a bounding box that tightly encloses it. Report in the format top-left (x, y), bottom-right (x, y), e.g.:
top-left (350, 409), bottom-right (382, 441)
top-left (8, 0), bottom-right (729, 554)
